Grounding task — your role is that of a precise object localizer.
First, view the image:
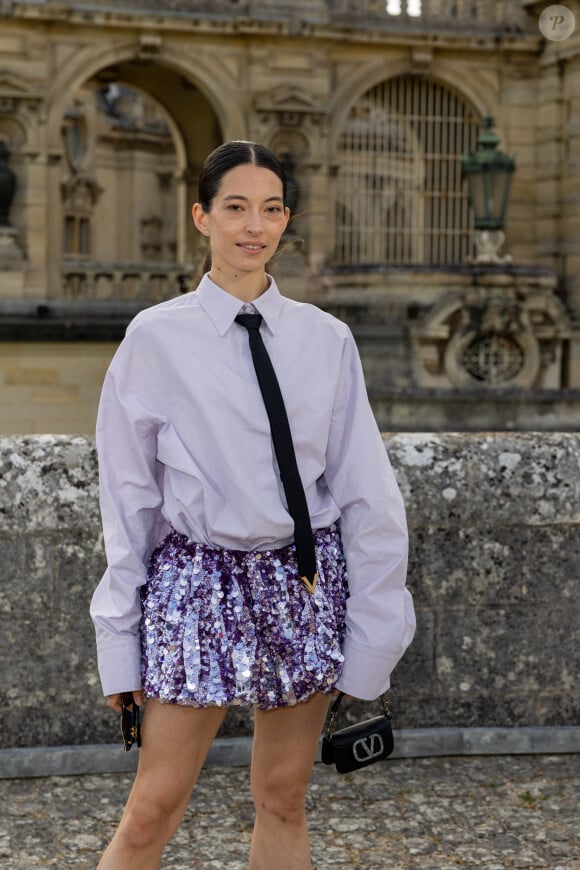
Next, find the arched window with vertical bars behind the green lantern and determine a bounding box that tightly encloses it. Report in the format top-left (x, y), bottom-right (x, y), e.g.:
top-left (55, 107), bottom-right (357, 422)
top-left (336, 76), bottom-right (479, 265)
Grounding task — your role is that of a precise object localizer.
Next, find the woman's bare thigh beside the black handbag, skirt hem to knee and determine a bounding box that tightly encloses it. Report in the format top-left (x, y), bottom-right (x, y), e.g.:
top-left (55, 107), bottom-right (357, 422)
top-left (252, 693), bottom-right (331, 798)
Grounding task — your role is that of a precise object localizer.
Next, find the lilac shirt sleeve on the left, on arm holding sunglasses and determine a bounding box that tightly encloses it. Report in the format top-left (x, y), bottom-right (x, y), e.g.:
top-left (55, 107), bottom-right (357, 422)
top-left (91, 352), bottom-right (164, 695)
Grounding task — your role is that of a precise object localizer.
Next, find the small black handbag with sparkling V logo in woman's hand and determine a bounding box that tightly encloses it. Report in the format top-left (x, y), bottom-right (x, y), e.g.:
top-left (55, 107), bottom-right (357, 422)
top-left (320, 692), bottom-right (395, 773)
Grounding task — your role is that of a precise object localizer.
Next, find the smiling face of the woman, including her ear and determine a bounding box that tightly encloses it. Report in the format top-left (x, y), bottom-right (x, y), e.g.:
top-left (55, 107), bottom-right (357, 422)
top-left (193, 163), bottom-right (290, 276)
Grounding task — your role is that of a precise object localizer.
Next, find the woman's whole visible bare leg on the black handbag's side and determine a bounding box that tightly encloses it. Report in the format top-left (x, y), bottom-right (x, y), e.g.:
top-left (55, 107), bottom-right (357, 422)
top-left (250, 694), bottom-right (329, 870)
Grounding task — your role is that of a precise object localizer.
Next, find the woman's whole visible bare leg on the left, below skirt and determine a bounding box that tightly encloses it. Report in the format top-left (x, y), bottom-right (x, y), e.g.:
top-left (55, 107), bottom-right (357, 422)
top-left (98, 700), bottom-right (226, 870)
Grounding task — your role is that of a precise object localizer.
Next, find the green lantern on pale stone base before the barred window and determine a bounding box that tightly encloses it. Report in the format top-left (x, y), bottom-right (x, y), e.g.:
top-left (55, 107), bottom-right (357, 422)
top-left (461, 116), bottom-right (516, 263)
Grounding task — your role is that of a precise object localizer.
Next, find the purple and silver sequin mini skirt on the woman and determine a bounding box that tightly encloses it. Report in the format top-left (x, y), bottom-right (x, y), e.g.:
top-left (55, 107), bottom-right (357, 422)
top-left (141, 524), bottom-right (347, 710)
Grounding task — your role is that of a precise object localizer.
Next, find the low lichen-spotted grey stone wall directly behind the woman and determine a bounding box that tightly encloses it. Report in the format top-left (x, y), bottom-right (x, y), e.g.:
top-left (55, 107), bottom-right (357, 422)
top-left (0, 433), bottom-right (580, 747)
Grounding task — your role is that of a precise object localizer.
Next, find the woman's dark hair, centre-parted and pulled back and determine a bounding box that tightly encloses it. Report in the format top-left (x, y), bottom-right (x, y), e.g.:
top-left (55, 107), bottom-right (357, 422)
top-left (198, 139), bottom-right (286, 213)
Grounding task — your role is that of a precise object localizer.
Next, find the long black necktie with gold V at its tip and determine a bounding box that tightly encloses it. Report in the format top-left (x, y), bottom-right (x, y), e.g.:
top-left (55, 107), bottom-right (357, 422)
top-left (236, 314), bottom-right (318, 592)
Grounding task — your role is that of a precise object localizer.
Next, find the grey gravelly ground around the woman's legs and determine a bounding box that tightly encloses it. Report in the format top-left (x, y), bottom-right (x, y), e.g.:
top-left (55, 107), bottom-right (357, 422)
top-left (0, 755), bottom-right (580, 870)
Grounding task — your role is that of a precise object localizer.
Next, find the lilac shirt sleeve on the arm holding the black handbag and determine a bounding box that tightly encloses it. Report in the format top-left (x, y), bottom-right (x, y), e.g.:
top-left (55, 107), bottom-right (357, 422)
top-left (324, 332), bottom-right (415, 700)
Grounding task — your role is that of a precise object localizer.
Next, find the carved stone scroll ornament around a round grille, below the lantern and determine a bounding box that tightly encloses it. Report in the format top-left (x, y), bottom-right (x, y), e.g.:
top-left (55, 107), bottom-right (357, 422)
top-left (411, 286), bottom-right (570, 389)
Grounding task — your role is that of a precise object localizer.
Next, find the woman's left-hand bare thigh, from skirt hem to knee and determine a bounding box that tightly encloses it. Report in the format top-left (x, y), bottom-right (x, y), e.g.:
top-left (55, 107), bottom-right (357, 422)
top-left (127, 699), bottom-right (227, 815)
